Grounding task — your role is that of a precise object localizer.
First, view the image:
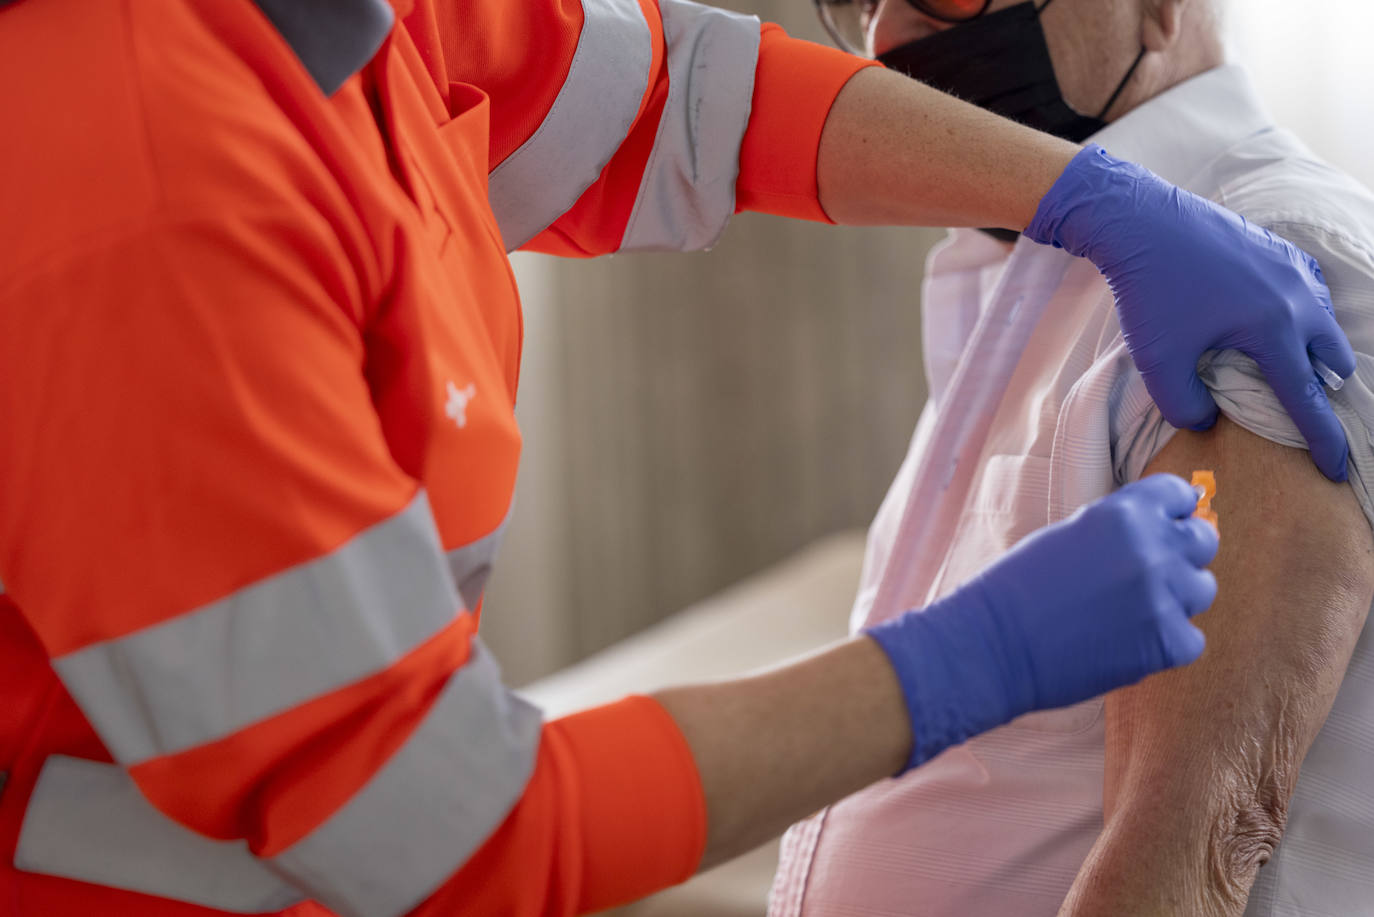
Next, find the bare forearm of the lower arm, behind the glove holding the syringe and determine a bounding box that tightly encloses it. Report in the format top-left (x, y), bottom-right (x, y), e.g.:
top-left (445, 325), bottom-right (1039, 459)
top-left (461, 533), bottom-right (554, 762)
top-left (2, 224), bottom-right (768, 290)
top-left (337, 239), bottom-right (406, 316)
top-left (657, 637), bottom-right (911, 868)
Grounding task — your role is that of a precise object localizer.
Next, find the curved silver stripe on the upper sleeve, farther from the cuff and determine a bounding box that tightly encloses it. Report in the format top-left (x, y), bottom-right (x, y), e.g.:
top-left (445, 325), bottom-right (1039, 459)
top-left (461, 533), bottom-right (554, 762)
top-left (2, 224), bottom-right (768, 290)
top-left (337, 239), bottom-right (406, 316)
top-left (488, 0), bottom-right (653, 252)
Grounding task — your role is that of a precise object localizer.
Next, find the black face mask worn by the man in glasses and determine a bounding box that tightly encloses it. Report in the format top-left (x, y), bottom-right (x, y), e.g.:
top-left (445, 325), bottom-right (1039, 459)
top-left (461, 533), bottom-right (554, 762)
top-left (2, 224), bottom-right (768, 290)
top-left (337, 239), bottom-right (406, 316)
top-left (878, 0), bottom-right (1145, 241)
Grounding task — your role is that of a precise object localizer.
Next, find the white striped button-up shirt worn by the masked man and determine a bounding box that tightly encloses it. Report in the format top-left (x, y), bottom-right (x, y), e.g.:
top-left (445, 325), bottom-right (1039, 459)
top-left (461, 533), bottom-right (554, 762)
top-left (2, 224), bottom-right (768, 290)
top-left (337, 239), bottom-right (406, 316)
top-left (769, 66), bottom-right (1374, 917)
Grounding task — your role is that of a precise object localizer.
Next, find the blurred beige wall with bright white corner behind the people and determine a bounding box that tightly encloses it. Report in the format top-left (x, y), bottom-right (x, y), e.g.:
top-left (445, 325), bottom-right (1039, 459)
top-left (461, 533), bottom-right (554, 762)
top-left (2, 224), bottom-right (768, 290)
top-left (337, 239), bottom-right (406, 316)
top-left (482, 0), bottom-right (1374, 685)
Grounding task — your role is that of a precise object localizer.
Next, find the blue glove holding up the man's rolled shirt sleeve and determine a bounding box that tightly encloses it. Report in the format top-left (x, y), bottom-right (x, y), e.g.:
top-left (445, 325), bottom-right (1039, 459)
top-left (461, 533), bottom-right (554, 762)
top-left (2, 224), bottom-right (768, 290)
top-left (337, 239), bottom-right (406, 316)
top-left (1025, 146), bottom-right (1355, 481)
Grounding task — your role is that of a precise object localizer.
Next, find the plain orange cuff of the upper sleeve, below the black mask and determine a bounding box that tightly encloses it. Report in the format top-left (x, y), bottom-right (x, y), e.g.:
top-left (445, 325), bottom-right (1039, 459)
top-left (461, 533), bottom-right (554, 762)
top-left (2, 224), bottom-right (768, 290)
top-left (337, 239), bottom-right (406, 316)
top-left (736, 23), bottom-right (881, 223)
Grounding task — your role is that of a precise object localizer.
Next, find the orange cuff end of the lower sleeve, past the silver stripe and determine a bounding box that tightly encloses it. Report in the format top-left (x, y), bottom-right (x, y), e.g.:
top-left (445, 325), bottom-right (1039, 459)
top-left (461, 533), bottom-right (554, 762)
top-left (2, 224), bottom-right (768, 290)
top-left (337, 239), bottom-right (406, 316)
top-left (415, 697), bottom-right (706, 917)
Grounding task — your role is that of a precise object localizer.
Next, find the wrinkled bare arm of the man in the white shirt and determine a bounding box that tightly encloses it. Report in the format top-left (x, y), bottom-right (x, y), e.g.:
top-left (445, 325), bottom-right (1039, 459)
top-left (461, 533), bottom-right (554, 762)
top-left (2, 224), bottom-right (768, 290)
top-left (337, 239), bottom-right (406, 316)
top-left (1061, 418), bottom-right (1374, 917)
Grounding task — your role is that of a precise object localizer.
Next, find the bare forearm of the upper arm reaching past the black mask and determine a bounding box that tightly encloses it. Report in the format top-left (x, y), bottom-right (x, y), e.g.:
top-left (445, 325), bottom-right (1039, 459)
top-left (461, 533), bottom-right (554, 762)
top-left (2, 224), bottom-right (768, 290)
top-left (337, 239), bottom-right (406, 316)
top-left (816, 69), bottom-right (1079, 230)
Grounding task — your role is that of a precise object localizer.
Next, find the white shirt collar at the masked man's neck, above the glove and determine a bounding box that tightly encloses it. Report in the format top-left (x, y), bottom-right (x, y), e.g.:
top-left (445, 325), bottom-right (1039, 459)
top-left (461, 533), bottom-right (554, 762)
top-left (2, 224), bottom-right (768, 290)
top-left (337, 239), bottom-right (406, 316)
top-left (1091, 65), bottom-right (1274, 195)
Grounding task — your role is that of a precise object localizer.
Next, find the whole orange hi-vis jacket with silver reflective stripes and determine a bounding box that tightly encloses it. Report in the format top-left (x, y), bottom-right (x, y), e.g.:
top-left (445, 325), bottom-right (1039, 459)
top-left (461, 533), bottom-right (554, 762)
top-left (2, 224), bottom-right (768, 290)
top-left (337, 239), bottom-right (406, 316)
top-left (0, 0), bottom-right (864, 917)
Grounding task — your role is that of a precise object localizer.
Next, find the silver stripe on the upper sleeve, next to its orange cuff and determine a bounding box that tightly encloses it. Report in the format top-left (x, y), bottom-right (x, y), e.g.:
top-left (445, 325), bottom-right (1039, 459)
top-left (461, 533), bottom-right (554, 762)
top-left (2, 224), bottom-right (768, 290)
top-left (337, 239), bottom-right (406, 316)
top-left (621, 0), bottom-right (760, 252)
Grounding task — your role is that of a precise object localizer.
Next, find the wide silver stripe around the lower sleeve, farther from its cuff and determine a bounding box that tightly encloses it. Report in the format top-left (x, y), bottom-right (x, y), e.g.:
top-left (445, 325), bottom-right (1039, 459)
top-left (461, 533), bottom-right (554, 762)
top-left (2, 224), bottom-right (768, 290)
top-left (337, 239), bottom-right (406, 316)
top-left (54, 491), bottom-right (459, 766)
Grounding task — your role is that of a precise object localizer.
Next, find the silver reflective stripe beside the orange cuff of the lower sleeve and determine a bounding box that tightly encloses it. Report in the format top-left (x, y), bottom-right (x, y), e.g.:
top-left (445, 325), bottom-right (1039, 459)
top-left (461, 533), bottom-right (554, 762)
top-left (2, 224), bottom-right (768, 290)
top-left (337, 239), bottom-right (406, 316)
top-left (272, 641), bottom-right (541, 917)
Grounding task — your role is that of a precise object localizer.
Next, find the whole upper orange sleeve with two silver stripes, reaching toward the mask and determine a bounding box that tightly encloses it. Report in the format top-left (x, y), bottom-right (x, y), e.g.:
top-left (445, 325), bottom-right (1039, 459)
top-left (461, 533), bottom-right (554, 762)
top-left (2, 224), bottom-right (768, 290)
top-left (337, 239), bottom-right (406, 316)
top-left (405, 0), bottom-right (877, 257)
